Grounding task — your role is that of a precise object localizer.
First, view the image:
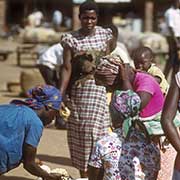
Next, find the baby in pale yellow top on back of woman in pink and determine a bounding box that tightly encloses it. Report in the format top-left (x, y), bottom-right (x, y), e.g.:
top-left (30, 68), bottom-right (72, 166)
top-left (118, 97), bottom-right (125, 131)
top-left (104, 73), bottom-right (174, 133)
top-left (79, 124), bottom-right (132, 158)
top-left (133, 47), bottom-right (169, 95)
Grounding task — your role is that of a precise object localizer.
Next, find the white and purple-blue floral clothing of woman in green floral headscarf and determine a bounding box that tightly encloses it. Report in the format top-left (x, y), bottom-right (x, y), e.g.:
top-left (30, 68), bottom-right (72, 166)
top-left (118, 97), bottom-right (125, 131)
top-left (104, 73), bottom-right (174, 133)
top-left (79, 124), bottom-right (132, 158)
top-left (89, 129), bottom-right (160, 180)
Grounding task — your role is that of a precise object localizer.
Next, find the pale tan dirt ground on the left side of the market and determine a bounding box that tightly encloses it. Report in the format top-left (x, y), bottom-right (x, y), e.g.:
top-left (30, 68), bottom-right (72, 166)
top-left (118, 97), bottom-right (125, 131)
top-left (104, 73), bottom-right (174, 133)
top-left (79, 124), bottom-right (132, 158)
top-left (0, 40), bottom-right (79, 180)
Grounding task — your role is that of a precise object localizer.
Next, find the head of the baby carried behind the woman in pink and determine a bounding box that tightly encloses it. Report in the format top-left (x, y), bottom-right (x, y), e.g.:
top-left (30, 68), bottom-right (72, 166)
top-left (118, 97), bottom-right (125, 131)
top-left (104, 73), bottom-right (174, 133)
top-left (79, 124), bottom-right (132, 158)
top-left (132, 46), bottom-right (154, 71)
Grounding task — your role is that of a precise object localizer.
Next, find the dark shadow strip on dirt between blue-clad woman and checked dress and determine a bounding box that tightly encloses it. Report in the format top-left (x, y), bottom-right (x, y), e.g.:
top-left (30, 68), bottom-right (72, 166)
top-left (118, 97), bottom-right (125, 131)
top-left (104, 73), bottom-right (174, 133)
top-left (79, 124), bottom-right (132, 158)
top-left (37, 154), bottom-right (72, 166)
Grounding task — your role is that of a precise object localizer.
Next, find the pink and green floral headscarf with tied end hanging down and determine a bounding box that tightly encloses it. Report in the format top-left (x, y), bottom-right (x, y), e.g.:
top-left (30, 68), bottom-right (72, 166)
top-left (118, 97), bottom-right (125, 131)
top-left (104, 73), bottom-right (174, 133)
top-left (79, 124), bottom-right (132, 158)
top-left (110, 90), bottom-right (141, 136)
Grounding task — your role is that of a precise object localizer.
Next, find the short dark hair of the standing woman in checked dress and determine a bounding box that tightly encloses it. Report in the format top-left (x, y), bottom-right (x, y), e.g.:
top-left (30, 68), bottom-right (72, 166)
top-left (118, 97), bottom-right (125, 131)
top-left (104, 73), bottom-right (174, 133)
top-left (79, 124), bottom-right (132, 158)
top-left (79, 1), bottom-right (99, 15)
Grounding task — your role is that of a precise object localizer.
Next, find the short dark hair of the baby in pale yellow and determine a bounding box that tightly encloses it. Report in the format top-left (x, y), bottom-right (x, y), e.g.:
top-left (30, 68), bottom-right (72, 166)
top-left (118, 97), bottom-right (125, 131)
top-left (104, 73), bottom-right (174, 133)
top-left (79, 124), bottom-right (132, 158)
top-left (132, 46), bottom-right (154, 60)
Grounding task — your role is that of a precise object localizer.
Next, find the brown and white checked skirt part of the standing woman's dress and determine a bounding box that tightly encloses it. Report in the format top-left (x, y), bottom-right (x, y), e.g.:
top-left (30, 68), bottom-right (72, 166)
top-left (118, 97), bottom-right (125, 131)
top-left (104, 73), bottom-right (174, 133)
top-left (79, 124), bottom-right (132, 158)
top-left (68, 80), bottom-right (110, 171)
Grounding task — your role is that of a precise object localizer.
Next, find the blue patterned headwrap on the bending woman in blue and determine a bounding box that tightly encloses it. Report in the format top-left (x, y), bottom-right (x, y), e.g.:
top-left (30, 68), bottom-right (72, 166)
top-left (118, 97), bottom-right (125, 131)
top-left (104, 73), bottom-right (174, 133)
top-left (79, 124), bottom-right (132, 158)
top-left (11, 85), bottom-right (62, 111)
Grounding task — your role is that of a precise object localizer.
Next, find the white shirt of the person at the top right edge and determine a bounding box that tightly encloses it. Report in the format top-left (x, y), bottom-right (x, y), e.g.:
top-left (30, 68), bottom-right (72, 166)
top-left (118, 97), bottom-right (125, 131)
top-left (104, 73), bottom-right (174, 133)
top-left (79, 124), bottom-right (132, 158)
top-left (165, 7), bottom-right (180, 37)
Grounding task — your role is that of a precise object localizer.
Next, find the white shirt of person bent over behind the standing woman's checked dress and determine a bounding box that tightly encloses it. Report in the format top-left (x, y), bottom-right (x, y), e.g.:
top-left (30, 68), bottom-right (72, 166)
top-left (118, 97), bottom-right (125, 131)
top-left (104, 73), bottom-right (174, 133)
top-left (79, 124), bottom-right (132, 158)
top-left (37, 43), bottom-right (63, 69)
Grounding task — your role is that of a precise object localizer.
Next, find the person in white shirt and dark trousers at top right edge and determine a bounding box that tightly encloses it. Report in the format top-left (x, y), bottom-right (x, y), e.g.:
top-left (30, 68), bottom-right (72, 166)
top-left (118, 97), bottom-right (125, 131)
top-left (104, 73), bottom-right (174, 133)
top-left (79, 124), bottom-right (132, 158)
top-left (164, 0), bottom-right (180, 78)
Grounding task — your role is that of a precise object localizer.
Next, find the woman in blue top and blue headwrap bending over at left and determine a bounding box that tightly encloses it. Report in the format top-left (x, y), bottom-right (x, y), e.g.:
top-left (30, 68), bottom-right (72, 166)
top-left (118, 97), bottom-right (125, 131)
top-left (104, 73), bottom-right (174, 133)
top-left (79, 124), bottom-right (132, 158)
top-left (0, 85), bottom-right (62, 180)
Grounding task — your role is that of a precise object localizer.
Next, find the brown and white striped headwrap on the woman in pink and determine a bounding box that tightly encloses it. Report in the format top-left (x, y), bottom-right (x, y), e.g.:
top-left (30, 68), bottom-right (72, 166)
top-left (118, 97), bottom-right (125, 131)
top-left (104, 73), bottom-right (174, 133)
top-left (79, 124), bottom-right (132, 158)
top-left (96, 55), bottom-right (122, 85)
